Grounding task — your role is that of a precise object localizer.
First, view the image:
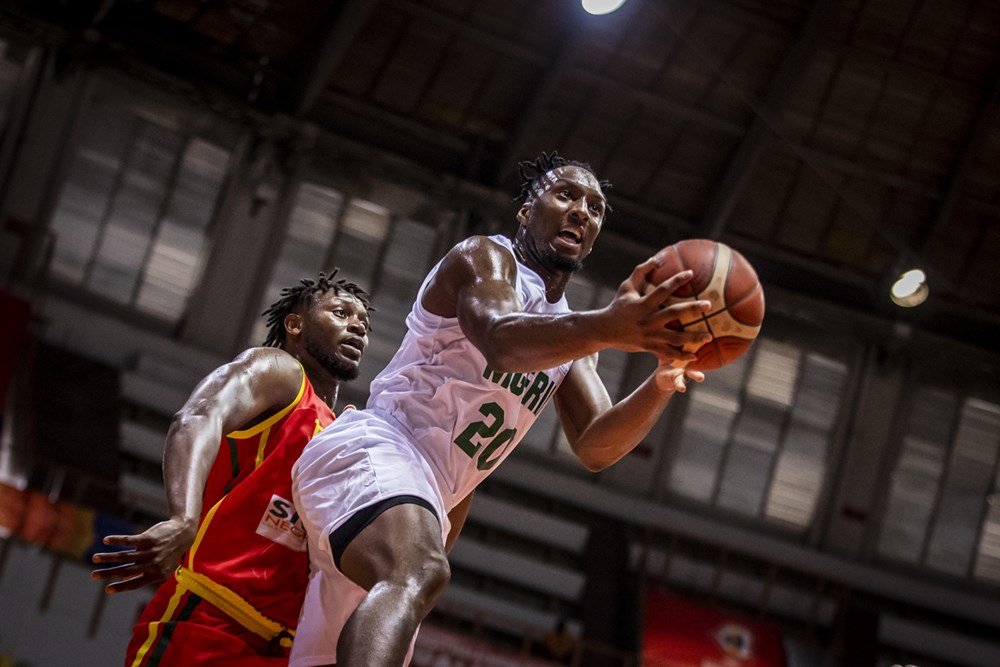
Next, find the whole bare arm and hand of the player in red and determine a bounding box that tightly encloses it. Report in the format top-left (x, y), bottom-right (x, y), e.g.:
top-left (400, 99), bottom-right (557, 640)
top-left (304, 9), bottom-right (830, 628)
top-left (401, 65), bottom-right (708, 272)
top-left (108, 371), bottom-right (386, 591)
top-left (91, 348), bottom-right (302, 593)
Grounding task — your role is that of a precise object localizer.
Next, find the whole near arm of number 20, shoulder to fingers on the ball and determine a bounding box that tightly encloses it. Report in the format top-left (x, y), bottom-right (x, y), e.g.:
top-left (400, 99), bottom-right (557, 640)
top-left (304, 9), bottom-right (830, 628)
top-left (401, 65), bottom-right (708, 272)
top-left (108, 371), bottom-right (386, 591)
top-left (423, 237), bottom-right (708, 372)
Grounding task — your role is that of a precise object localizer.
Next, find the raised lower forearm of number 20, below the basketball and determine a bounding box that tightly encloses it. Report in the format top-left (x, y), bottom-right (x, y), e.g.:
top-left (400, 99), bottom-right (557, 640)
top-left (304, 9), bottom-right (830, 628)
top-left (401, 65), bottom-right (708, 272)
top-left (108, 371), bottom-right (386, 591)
top-left (572, 376), bottom-right (673, 472)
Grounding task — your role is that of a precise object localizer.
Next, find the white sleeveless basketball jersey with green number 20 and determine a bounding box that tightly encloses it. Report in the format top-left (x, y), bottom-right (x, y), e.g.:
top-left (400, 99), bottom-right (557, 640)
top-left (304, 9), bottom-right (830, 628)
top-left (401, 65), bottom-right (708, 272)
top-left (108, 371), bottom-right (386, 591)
top-left (368, 235), bottom-right (572, 509)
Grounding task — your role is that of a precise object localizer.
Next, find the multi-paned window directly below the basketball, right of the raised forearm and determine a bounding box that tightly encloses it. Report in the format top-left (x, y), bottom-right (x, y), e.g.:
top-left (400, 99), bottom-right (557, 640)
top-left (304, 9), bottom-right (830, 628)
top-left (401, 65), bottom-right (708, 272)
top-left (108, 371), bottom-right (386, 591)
top-left (667, 338), bottom-right (848, 529)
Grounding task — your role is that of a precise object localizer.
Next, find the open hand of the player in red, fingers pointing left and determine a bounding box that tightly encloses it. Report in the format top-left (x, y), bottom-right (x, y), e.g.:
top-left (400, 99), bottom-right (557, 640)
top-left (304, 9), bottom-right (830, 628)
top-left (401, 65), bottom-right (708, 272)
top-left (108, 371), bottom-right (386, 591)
top-left (90, 518), bottom-right (197, 593)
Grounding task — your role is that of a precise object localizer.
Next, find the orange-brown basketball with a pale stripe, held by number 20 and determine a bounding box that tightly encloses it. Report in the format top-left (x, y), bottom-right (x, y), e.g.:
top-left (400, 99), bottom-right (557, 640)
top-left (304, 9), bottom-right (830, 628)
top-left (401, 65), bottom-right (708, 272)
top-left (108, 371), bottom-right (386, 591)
top-left (649, 239), bottom-right (764, 371)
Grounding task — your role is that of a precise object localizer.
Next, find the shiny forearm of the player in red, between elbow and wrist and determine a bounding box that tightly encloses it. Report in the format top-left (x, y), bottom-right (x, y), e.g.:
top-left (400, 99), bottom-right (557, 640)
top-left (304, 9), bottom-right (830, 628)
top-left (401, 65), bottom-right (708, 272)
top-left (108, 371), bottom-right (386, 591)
top-left (163, 414), bottom-right (222, 524)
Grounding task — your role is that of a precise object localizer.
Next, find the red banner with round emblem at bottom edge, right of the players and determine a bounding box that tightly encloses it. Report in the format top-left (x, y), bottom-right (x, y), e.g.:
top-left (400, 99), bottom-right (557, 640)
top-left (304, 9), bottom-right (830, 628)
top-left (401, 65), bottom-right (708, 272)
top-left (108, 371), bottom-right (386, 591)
top-left (642, 589), bottom-right (785, 667)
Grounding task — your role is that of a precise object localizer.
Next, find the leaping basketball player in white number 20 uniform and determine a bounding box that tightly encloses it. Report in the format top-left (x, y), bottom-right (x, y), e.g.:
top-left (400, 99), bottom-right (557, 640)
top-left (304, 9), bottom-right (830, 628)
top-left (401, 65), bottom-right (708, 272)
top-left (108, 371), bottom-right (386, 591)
top-left (290, 154), bottom-right (708, 667)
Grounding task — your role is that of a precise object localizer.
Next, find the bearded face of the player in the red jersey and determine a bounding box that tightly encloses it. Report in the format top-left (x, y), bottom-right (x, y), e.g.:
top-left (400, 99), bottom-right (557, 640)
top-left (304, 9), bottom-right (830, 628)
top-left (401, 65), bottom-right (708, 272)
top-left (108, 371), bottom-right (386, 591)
top-left (302, 290), bottom-right (368, 381)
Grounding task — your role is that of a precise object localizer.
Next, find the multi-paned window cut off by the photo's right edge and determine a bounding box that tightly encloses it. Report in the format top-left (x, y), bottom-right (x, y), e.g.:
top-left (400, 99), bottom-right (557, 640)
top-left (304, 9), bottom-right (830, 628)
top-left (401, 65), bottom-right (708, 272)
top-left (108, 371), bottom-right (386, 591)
top-left (878, 384), bottom-right (1000, 582)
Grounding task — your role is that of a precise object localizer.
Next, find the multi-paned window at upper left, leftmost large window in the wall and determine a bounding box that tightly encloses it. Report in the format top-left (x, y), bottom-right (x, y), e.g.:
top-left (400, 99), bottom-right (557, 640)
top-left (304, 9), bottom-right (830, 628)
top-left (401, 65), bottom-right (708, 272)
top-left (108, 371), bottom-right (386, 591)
top-left (51, 92), bottom-right (230, 323)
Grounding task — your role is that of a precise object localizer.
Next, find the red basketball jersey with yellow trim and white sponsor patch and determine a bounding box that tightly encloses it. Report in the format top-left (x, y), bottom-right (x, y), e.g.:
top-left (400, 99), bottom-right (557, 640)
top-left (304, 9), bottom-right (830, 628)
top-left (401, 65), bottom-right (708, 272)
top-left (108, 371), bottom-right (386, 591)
top-left (181, 372), bottom-right (334, 628)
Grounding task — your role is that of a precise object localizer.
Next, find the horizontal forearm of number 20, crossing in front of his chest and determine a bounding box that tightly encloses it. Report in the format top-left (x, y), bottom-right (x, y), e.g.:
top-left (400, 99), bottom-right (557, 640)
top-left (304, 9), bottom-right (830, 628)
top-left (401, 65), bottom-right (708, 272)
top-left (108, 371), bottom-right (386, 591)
top-left (479, 310), bottom-right (613, 373)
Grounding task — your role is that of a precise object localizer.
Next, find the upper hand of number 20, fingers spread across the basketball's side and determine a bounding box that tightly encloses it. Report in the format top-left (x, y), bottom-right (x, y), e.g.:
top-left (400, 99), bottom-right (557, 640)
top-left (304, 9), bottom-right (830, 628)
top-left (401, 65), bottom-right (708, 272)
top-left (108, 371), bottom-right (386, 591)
top-left (603, 257), bottom-right (712, 362)
